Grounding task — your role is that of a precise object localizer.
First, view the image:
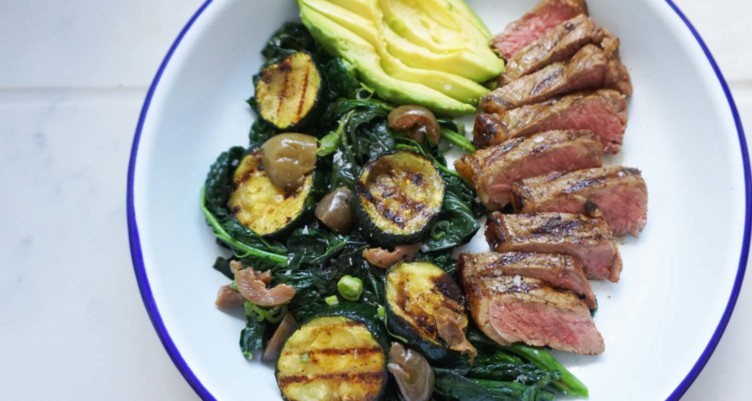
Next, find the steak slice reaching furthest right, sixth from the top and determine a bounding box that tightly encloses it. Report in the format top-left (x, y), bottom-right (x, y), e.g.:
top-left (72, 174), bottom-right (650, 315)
top-left (513, 166), bottom-right (648, 237)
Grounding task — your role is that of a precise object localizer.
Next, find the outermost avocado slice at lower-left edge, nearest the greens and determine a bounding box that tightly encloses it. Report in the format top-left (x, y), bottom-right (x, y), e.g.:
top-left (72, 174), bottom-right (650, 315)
top-left (297, 0), bottom-right (475, 116)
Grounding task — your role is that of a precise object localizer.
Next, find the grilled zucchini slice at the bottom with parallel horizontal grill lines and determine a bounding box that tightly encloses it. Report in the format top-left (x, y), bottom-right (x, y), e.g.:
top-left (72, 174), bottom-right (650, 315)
top-left (276, 316), bottom-right (387, 401)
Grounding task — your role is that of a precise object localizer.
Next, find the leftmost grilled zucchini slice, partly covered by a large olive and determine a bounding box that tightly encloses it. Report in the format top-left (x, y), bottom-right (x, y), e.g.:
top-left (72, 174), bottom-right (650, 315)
top-left (229, 148), bottom-right (314, 236)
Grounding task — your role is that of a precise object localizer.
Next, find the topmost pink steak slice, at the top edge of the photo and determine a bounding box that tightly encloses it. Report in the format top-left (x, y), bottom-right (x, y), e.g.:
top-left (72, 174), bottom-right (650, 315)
top-left (491, 0), bottom-right (588, 59)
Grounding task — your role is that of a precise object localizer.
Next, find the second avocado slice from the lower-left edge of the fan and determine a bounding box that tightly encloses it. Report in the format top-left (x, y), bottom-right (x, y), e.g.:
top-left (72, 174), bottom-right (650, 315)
top-left (302, 0), bottom-right (488, 104)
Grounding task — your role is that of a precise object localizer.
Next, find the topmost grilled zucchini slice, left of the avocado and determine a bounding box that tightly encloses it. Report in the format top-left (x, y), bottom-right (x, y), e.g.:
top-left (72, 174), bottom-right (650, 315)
top-left (255, 51), bottom-right (324, 131)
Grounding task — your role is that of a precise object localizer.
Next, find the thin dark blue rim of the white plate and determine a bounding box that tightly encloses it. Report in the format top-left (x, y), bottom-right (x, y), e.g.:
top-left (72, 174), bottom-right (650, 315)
top-left (126, 0), bottom-right (752, 401)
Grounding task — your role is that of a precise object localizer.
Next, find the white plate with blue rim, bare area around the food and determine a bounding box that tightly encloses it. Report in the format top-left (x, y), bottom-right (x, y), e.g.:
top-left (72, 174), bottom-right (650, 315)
top-left (128, 0), bottom-right (750, 401)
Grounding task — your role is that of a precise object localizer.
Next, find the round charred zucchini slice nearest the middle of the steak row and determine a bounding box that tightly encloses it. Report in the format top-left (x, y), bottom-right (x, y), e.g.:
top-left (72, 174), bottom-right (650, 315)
top-left (355, 150), bottom-right (444, 247)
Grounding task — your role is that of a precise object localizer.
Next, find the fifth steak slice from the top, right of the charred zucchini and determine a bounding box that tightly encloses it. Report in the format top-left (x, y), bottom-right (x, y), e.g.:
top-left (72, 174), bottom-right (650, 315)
top-left (454, 131), bottom-right (603, 210)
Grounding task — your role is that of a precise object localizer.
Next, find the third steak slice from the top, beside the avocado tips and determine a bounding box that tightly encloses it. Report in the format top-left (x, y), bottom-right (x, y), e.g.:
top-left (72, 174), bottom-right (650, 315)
top-left (479, 45), bottom-right (632, 114)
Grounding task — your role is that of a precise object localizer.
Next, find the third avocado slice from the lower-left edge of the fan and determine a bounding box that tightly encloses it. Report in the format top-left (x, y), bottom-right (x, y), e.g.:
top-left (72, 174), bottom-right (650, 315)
top-left (330, 0), bottom-right (503, 82)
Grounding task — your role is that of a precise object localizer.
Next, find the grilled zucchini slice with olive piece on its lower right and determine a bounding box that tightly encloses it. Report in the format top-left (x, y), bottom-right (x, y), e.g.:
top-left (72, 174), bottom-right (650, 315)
top-left (386, 262), bottom-right (476, 365)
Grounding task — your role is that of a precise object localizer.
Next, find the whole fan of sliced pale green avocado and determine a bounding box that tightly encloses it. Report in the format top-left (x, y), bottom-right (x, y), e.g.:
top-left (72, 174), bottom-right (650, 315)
top-left (297, 0), bottom-right (504, 116)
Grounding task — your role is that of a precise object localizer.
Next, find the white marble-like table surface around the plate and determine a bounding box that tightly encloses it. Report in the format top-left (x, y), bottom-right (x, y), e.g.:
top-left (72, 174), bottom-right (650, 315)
top-left (0, 0), bottom-right (752, 401)
